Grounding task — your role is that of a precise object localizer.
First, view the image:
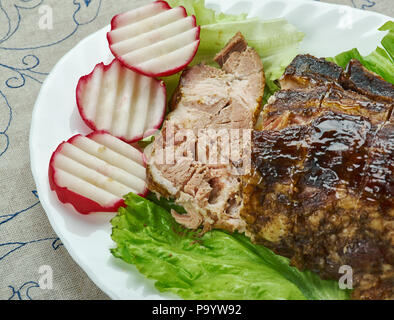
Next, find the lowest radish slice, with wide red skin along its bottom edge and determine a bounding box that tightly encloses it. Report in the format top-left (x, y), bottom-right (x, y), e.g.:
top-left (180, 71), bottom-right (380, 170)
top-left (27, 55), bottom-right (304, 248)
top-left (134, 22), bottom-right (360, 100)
top-left (49, 132), bottom-right (148, 214)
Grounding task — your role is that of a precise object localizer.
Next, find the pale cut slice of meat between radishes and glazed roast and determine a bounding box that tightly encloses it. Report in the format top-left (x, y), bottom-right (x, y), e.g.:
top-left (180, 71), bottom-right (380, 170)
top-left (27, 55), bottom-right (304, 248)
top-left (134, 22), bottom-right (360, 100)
top-left (146, 33), bottom-right (265, 232)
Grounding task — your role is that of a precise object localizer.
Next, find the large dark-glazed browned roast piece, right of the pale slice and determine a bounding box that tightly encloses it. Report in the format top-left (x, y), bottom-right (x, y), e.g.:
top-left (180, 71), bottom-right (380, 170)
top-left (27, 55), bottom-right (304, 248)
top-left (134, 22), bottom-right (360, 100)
top-left (245, 55), bottom-right (394, 299)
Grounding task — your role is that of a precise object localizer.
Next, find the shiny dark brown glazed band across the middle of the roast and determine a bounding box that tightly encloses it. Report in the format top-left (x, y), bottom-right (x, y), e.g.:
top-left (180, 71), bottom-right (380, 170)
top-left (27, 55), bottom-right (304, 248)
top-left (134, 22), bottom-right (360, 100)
top-left (252, 111), bottom-right (394, 211)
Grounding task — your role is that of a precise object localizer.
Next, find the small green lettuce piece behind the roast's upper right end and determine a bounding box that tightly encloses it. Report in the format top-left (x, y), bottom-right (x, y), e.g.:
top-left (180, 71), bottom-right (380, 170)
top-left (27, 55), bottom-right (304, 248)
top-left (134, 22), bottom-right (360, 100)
top-left (327, 21), bottom-right (394, 84)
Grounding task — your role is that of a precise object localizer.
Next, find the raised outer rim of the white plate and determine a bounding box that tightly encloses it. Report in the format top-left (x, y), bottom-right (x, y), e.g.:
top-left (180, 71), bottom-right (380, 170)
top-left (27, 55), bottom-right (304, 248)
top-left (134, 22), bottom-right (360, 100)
top-left (29, 0), bottom-right (393, 300)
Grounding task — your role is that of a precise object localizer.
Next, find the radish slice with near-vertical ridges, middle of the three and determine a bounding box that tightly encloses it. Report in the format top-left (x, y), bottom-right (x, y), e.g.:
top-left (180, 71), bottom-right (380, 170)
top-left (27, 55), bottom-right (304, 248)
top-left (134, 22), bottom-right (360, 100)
top-left (77, 59), bottom-right (166, 143)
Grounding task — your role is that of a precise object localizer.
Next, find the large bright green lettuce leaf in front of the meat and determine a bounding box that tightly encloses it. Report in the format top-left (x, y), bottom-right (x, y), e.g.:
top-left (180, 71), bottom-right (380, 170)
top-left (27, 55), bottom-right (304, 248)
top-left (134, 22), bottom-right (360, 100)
top-left (111, 194), bottom-right (348, 300)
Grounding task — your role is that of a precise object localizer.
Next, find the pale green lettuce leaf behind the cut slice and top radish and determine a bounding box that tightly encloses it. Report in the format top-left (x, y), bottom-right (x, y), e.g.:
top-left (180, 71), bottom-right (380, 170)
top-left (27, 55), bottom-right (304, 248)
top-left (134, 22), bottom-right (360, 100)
top-left (163, 0), bottom-right (304, 101)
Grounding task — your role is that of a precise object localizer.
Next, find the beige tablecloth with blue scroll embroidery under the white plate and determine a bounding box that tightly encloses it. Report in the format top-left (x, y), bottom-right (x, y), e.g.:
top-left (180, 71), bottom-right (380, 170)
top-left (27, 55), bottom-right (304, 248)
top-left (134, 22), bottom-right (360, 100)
top-left (0, 0), bottom-right (394, 300)
